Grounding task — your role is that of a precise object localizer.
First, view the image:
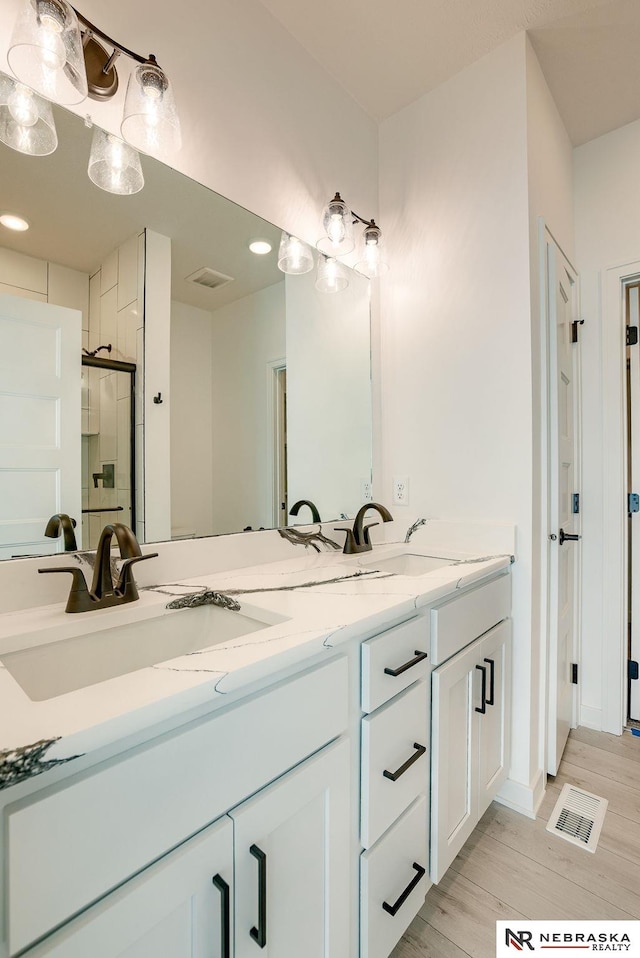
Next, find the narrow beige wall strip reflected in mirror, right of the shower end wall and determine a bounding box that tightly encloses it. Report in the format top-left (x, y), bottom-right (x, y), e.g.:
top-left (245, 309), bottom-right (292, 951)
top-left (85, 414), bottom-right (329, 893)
top-left (170, 301), bottom-right (215, 538)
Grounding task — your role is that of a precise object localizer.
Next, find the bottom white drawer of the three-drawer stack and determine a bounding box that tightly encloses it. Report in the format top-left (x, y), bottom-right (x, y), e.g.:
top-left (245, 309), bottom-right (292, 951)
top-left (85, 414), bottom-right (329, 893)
top-left (360, 795), bottom-right (431, 958)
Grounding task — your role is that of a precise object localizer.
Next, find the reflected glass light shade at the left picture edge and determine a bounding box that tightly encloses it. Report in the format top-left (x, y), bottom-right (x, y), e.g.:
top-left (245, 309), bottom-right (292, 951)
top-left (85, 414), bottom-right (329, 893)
top-left (0, 74), bottom-right (58, 156)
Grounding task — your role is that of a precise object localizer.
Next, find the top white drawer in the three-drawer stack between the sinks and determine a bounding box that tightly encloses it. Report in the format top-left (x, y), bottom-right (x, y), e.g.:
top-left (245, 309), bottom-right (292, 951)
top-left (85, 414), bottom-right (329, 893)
top-left (362, 616), bottom-right (429, 712)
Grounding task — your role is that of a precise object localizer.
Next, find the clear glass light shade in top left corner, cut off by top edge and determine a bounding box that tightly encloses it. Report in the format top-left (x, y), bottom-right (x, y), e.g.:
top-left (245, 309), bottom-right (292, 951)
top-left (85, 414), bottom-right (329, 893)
top-left (7, 0), bottom-right (87, 106)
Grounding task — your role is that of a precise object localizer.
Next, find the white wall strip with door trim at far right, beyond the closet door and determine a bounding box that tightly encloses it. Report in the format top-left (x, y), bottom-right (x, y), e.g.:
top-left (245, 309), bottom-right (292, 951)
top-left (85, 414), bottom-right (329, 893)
top-left (574, 122), bottom-right (640, 732)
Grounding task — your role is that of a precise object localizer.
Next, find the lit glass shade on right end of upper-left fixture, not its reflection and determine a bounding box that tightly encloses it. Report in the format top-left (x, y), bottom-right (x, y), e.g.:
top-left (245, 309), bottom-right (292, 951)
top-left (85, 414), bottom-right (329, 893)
top-left (120, 58), bottom-right (182, 158)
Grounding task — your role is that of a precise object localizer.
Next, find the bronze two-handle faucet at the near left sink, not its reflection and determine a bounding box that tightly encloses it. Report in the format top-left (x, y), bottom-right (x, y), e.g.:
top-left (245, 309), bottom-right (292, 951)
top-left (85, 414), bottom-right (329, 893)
top-left (38, 522), bottom-right (158, 612)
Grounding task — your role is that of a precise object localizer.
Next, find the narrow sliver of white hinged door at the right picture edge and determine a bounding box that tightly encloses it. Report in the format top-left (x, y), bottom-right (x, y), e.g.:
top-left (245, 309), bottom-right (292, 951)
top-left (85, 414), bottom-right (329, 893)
top-left (627, 285), bottom-right (640, 721)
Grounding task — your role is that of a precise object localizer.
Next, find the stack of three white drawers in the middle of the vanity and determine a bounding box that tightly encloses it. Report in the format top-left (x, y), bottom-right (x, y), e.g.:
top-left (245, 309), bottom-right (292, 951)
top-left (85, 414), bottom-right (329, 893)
top-left (360, 615), bottom-right (430, 958)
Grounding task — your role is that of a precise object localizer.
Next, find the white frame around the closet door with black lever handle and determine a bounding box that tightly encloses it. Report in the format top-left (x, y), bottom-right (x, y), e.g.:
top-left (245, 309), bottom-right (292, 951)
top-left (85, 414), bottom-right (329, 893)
top-left (537, 218), bottom-right (582, 774)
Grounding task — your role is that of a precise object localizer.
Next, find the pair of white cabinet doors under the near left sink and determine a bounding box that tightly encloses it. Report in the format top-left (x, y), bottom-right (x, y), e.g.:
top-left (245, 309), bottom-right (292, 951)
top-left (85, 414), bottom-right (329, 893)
top-left (28, 740), bottom-right (349, 958)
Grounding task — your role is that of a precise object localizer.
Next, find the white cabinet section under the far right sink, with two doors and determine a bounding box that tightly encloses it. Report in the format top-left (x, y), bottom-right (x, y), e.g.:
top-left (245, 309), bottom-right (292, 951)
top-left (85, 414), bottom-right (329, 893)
top-left (431, 576), bottom-right (511, 882)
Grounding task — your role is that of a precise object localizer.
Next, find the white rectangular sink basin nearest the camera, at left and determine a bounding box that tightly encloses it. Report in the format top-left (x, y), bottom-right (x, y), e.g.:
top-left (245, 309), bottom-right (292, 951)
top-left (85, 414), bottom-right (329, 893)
top-left (0, 605), bottom-right (273, 702)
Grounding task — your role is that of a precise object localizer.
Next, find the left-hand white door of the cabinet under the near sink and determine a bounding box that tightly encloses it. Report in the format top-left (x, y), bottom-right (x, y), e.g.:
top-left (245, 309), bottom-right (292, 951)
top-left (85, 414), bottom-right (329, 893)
top-left (29, 816), bottom-right (233, 958)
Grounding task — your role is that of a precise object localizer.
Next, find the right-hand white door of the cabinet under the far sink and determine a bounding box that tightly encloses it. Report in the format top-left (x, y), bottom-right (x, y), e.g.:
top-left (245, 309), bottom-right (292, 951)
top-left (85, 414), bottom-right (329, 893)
top-left (477, 619), bottom-right (511, 819)
